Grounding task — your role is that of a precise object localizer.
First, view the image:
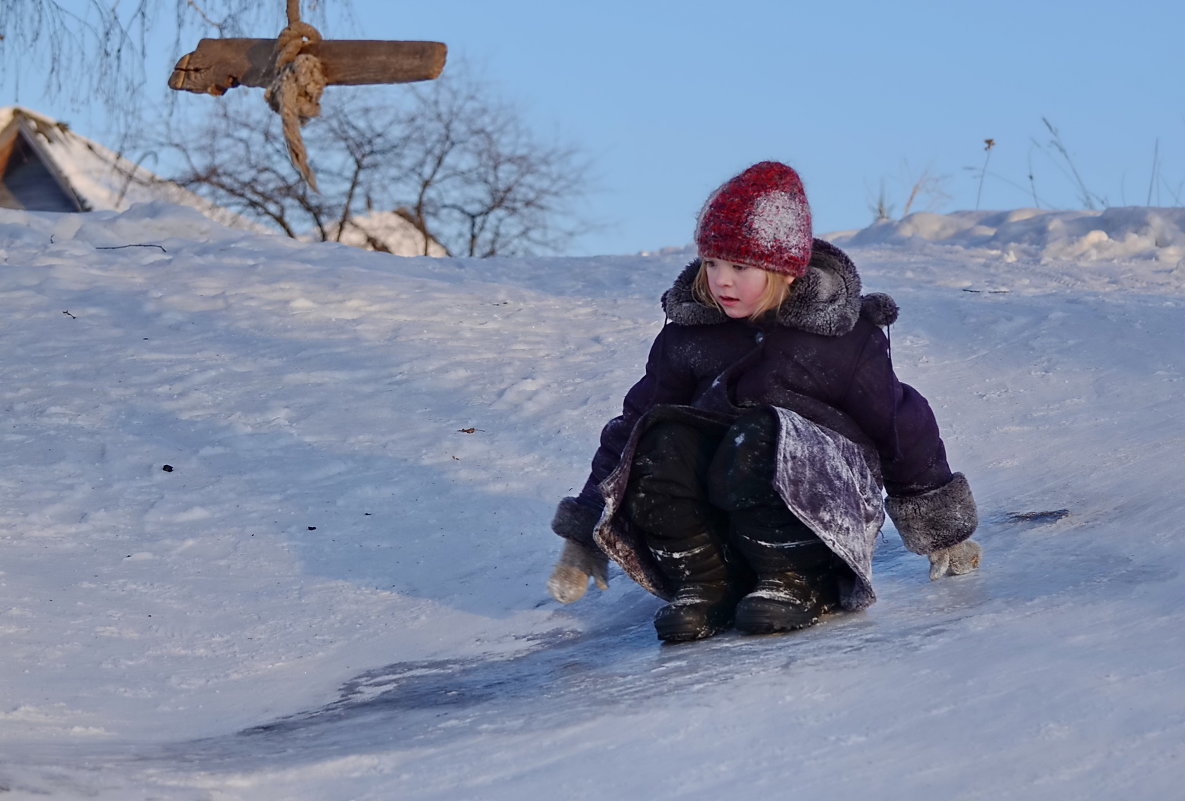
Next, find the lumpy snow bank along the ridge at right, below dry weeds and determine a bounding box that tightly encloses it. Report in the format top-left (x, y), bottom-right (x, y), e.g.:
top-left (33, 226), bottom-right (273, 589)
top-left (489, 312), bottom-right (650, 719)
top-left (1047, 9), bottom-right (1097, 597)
top-left (827, 206), bottom-right (1185, 264)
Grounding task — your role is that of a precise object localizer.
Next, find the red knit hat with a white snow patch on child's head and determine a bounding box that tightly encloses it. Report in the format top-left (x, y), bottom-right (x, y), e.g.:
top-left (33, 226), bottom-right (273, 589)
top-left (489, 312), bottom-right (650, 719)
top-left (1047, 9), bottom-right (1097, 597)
top-left (696, 161), bottom-right (812, 276)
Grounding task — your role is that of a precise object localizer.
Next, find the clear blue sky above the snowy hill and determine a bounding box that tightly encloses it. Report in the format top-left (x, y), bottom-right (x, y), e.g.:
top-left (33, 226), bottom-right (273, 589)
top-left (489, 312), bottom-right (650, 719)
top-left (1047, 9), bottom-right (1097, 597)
top-left (0, 0), bottom-right (1185, 255)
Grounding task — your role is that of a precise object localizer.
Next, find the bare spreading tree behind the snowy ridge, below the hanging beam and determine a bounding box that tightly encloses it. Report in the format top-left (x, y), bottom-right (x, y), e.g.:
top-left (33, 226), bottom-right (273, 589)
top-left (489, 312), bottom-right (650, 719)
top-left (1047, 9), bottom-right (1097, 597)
top-left (136, 69), bottom-right (589, 257)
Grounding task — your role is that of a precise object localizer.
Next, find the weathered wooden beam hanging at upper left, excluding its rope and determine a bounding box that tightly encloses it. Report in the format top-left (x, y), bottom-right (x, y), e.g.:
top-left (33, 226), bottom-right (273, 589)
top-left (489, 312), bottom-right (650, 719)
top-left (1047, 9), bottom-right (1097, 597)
top-left (168, 39), bottom-right (448, 95)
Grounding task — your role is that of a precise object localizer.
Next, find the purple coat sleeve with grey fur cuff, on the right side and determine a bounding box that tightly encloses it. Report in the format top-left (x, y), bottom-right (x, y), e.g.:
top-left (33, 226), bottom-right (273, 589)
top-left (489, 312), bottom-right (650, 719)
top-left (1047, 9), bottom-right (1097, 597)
top-left (845, 329), bottom-right (979, 553)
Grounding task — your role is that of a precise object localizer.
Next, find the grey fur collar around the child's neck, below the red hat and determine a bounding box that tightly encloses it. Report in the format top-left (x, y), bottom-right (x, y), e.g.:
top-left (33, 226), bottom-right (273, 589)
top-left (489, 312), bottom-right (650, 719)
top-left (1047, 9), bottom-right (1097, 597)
top-left (662, 239), bottom-right (898, 337)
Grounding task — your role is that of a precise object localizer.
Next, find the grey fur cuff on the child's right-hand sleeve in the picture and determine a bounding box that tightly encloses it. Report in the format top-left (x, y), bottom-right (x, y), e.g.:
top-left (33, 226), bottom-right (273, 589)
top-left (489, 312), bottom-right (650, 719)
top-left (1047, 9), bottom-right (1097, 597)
top-left (885, 473), bottom-right (979, 553)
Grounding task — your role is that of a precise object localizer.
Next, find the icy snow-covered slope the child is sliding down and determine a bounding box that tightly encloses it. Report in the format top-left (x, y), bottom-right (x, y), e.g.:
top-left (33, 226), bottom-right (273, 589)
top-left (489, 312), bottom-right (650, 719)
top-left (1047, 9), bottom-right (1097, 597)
top-left (0, 205), bottom-right (1185, 801)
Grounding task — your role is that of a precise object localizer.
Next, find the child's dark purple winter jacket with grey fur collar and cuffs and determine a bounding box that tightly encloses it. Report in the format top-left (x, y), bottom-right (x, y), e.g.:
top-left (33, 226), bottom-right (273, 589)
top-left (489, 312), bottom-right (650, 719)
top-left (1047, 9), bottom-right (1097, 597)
top-left (552, 239), bottom-right (978, 603)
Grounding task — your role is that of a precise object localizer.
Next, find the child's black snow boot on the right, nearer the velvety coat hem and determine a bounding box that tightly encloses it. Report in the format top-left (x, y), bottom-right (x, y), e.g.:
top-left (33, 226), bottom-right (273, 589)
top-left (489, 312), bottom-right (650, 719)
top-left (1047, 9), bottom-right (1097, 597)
top-left (732, 510), bottom-right (839, 634)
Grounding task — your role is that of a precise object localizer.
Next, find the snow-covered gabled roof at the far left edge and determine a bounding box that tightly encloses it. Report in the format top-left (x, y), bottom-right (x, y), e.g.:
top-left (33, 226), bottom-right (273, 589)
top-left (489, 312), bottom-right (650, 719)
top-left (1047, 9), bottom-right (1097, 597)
top-left (0, 107), bottom-right (258, 229)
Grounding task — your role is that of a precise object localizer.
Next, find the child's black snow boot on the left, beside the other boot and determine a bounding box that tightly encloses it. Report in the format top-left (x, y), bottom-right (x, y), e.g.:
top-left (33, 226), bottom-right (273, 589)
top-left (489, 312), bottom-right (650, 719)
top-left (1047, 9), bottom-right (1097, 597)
top-left (651, 531), bottom-right (737, 642)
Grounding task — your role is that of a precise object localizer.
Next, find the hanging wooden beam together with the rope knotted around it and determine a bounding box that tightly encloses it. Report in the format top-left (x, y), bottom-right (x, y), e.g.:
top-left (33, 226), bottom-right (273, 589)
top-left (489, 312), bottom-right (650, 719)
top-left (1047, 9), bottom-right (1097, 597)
top-left (168, 13), bottom-right (448, 191)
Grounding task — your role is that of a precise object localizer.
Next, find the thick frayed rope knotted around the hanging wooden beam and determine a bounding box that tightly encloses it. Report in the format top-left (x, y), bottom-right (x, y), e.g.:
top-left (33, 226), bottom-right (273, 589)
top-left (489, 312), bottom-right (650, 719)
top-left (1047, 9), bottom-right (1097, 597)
top-left (263, 0), bottom-right (326, 192)
